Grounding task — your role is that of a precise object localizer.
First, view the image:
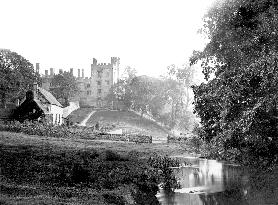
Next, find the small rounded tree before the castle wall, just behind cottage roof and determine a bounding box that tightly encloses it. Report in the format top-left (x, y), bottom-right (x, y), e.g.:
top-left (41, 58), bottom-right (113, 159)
top-left (50, 72), bottom-right (79, 106)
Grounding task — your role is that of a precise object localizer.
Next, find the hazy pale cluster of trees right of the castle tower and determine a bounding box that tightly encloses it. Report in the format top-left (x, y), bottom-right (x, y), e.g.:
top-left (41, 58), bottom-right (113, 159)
top-left (107, 65), bottom-right (197, 129)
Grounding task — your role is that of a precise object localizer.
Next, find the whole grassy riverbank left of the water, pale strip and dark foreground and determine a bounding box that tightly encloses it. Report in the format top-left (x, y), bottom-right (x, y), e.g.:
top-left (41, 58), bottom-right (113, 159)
top-left (0, 132), bottom-right (191, 205)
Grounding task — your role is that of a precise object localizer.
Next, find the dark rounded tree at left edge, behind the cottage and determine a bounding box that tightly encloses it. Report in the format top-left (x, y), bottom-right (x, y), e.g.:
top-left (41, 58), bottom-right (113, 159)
top-left (0, 49), bottom-right (40, 107)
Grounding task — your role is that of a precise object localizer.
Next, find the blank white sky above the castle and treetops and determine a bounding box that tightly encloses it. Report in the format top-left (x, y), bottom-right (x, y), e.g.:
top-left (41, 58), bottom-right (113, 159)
top-left (0, 0), bottom-right (213, 77)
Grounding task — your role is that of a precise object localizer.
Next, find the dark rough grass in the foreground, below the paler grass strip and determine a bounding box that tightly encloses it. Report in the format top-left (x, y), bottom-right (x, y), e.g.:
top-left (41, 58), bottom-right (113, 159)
top-left (0, 145), bottom-right (159, 204)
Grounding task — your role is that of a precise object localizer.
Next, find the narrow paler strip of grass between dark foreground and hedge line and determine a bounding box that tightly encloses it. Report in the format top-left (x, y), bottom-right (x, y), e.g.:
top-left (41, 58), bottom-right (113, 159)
top-left (0, 132), bottom-right (187, 157)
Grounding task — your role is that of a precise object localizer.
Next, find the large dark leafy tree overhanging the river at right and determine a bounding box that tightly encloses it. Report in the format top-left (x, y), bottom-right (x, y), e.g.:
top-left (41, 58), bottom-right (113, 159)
top-left (191, 0), bottom-right (278, 162)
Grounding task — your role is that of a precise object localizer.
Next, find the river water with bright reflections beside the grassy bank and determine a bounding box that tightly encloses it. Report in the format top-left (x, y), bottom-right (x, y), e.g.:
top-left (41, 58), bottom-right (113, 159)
top-left (157, 158), bottom-right (278, 205)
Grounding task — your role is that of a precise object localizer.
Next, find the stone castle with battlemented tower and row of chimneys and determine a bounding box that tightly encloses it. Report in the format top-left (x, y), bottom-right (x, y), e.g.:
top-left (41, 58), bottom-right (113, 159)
top-left (40, 57), bottom-right (120, 108)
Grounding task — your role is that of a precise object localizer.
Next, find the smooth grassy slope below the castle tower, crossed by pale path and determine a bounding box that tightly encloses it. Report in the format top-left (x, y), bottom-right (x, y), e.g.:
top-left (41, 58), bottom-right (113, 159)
top-left (70, 108), bottom-right (168, 141)
